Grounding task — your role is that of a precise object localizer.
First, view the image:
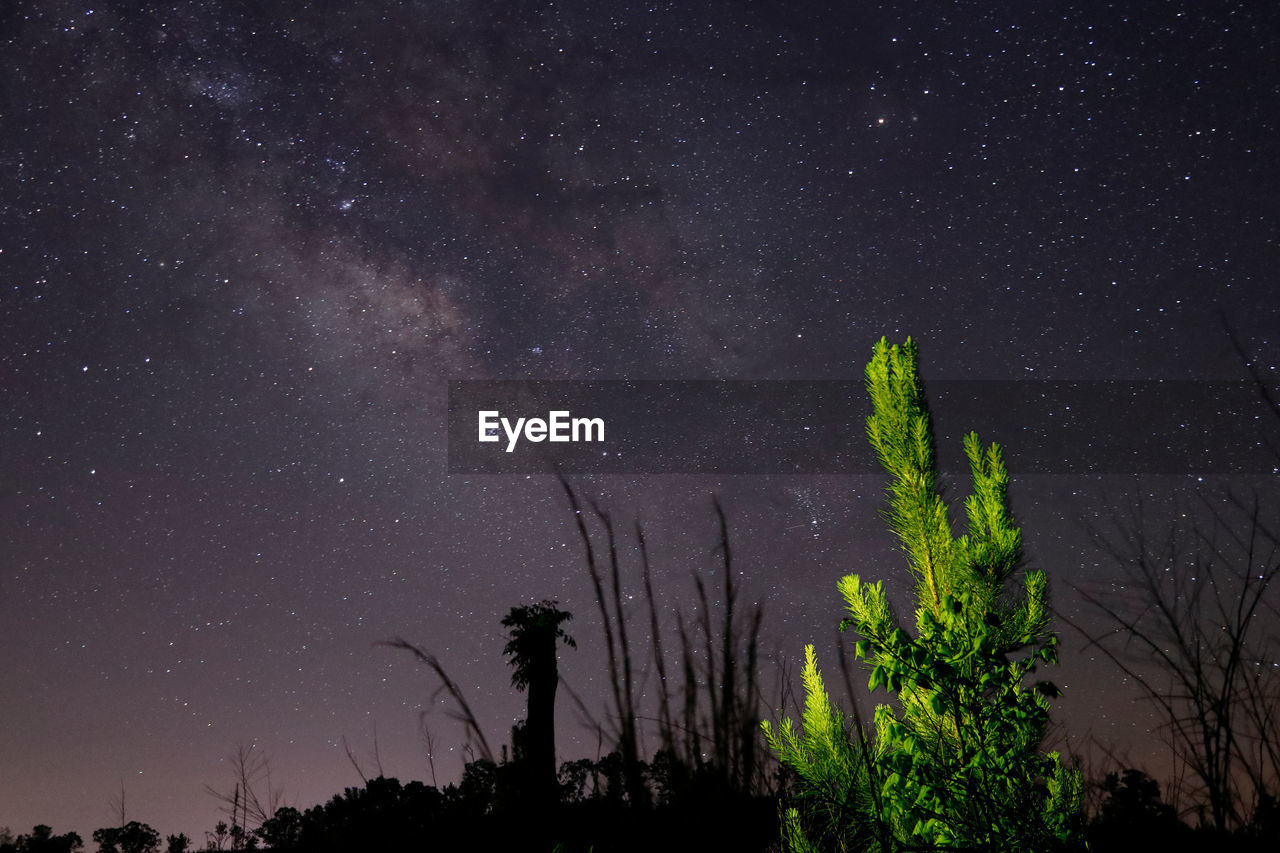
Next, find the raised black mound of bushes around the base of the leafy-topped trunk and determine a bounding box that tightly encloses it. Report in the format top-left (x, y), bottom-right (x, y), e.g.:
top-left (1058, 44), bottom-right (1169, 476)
top-left (220, 753), bottom-right (777, 853)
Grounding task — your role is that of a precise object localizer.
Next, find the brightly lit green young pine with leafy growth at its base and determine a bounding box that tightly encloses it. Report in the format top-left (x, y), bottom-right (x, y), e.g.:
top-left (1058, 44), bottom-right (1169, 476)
top-left (764, 338), bottom-right (1080, 853)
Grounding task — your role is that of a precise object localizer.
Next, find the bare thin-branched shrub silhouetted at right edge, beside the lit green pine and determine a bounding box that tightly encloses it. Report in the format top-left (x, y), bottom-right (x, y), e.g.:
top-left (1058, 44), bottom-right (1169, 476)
top-left (1076, 496), bottom-right (1280, 830)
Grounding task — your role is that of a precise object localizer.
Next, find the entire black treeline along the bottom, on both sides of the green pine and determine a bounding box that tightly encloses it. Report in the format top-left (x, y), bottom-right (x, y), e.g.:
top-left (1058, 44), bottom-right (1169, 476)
top-left (10, 752), bottom-right (1280, 853)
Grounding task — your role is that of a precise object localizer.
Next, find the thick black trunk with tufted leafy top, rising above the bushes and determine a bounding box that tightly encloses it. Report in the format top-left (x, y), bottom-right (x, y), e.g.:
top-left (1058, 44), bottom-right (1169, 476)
top-left (502, 599), bottom-right (576, 806)
